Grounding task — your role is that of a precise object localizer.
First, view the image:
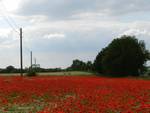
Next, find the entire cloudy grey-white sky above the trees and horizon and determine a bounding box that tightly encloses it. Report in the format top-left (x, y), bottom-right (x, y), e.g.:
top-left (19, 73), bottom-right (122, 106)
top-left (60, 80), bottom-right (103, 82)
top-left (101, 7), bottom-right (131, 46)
top-left (0, 0), bottom-right (150, 68)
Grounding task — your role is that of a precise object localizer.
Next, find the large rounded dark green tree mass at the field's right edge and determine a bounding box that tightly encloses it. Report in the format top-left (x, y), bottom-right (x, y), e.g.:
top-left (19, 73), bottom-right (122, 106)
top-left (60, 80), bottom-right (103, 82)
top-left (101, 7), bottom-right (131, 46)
top-left (94, 35), bottom-right (150, 76)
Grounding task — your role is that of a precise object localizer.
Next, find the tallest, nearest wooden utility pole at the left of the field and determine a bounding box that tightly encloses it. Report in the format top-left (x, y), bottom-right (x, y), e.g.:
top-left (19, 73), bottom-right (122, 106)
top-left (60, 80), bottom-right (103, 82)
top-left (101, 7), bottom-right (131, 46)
top-left (20, 28), bottom-right (23, 76)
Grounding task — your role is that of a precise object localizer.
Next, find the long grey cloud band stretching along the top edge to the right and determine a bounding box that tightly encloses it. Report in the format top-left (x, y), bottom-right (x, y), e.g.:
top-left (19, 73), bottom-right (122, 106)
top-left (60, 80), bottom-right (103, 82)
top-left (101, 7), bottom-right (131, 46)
top-left (19, 0), bottom-right (150, 19)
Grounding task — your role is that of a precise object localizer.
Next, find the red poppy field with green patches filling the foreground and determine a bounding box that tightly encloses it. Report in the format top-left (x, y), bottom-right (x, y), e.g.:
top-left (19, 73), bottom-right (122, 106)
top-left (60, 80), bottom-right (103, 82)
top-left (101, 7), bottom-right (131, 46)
top-left (0, 76), bottom-right (150, 113)
